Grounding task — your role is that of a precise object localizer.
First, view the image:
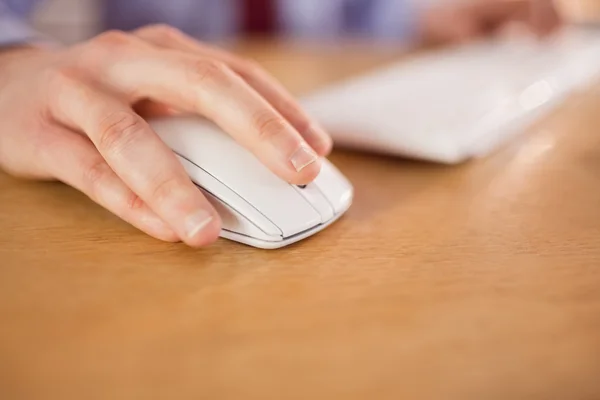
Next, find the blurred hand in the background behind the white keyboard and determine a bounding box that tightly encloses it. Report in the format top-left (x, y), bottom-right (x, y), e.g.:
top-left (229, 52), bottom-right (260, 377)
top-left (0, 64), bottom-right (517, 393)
top-left (421, 0), bottom-right (561, 43)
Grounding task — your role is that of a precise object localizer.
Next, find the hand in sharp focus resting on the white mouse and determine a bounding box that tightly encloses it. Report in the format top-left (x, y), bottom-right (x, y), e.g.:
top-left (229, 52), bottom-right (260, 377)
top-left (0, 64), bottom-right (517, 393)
top-left (0, 26), bottom-right (331, 246)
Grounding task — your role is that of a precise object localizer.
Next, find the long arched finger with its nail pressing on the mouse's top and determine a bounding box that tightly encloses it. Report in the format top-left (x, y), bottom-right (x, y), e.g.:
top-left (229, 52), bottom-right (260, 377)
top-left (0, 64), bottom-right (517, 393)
top-left (84, 34), bottom-right (321, 184)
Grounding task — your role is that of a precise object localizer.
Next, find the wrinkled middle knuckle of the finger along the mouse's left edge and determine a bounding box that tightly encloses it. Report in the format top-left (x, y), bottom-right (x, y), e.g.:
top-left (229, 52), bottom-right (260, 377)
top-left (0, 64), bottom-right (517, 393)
top-left (98, 111), bottom-right (145, 158)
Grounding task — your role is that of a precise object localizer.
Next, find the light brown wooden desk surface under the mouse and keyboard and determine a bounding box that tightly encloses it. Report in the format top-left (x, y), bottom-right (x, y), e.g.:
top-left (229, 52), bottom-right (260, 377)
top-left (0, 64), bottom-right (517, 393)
top-left (0, 41), bottom-right (600, 400)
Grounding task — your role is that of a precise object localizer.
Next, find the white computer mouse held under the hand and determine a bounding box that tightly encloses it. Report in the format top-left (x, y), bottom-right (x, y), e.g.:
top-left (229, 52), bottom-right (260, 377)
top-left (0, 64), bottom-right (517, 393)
top-left (149, 116), bottom-right (354, 249)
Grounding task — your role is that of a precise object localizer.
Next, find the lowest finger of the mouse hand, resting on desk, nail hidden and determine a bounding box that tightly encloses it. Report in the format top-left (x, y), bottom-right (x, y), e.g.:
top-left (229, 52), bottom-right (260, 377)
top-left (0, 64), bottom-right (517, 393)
top-left (40, 129), bottom-right (179, 242)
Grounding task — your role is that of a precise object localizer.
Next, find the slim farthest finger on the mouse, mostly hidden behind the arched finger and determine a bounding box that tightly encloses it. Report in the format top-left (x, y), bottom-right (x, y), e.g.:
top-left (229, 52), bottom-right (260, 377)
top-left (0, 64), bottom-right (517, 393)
top-left (134, 25), bottom-right (332, 156)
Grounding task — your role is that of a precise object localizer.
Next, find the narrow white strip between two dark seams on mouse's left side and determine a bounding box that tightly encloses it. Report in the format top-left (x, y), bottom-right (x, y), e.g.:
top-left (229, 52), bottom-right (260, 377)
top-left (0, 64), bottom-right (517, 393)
top-left (176, 154), bottom-right (283, 237)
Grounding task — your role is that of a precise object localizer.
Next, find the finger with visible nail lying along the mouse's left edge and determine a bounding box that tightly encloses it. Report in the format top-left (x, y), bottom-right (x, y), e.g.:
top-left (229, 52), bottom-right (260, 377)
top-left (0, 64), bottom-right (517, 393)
top-left (51, 73), bottom-right (220, 246)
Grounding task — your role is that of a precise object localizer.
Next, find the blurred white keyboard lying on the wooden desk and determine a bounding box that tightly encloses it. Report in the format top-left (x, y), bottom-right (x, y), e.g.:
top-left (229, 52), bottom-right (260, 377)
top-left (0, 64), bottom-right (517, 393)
top-left (303, 31), bottom-right (600, 164)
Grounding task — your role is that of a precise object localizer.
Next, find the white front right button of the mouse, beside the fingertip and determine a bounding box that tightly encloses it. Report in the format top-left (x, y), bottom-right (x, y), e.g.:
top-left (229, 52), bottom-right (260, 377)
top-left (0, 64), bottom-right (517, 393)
top-left (313, 160), bottom-right (354, 214)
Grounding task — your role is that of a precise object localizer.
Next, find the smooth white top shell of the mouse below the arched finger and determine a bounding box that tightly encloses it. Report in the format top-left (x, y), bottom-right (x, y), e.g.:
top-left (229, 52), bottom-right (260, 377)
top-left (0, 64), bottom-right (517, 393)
top-left (151, 117), bottom-right (321, 237)
